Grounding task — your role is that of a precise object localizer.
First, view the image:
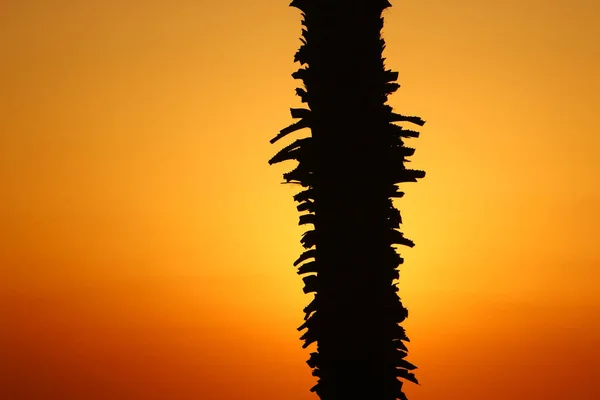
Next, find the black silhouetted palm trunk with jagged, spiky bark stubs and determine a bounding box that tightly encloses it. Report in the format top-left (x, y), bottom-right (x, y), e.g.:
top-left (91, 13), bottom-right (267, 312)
top-left (269, 0), bottom-right (425, 400)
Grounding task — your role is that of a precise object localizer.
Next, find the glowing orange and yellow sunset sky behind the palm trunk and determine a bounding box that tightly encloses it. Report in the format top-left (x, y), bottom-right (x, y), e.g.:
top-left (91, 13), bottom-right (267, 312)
top-left (0, 0), bottom-right (600, 400)
